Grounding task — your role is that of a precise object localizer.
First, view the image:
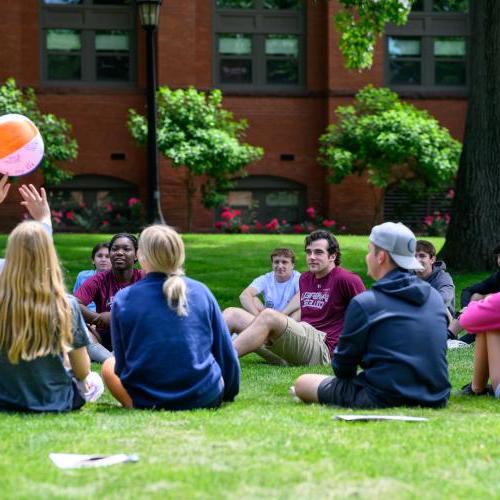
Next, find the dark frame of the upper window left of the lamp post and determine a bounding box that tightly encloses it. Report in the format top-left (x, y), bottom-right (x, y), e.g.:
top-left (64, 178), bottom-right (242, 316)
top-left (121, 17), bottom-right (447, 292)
top-left (38, 0), bottom-right (137, 88)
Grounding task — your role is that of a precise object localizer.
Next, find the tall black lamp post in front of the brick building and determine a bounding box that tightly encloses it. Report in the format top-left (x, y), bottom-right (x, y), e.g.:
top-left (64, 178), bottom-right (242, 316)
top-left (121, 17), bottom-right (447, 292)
top-left (136, 0), bottom-right (165, 223)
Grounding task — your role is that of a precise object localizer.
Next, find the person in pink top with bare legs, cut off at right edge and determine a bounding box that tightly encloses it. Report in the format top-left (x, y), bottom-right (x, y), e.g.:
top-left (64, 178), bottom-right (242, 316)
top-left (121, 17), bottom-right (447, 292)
top-left (459, 293), bottom-right (500, 398)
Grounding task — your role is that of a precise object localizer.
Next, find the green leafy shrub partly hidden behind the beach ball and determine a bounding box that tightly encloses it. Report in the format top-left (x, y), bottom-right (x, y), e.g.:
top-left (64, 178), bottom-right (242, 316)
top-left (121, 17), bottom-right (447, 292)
top-left (0, 78), bottom-right (78, 185)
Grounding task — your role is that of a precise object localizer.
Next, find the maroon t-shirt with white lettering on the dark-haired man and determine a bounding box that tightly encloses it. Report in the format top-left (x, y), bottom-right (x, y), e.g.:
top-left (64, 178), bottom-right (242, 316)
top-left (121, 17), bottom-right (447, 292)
top-left (299, 267), bottom-right (365, 354)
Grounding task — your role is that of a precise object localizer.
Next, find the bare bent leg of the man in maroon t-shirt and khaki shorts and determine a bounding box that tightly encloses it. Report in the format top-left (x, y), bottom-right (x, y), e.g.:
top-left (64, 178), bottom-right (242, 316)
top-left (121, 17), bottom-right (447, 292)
top-left (234, 309), bottom-right (287, 358)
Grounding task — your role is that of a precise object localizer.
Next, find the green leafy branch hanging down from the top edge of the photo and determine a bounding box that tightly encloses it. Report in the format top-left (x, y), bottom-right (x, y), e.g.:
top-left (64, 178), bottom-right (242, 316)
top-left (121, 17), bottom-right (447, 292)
top-left (335, 0), bottom-right (412, 69)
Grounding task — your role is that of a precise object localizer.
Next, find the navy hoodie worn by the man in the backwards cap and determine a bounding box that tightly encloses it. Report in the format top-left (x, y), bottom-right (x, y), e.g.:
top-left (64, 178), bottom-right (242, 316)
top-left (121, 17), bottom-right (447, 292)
top-left (332, 269), bottom-right (450, 407)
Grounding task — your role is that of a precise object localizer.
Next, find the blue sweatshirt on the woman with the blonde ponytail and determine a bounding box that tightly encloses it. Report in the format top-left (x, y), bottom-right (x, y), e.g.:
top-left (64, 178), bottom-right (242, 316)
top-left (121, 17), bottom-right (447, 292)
top-left (111, 273), bottom-right (240, 410)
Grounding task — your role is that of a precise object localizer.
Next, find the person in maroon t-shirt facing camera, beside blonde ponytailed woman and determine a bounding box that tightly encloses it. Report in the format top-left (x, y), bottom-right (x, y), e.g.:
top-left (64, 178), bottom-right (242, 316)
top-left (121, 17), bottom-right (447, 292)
top-left (75, 233), bottom-right (144, 361)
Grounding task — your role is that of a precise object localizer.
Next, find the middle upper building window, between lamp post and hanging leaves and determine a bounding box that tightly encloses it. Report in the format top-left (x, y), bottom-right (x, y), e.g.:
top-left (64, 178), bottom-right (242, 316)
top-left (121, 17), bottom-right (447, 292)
top-left (214, 0), bottom-right (305, 90)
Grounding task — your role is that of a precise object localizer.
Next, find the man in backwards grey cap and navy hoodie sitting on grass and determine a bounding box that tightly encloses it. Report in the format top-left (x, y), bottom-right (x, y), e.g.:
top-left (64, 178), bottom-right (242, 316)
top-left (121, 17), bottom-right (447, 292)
top-left (294, 222), bottom-right (450, 408)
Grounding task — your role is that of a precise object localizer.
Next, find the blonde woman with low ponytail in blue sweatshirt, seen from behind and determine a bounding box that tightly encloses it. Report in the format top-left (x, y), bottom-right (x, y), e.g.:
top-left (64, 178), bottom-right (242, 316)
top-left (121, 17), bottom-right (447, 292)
top-left (102, 225), bottom-right (240, 410)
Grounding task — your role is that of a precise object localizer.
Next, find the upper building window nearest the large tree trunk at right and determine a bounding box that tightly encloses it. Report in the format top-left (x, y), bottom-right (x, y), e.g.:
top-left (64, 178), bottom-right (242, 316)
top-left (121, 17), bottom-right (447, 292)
top-left (386, 0), bottom-right (468, 90)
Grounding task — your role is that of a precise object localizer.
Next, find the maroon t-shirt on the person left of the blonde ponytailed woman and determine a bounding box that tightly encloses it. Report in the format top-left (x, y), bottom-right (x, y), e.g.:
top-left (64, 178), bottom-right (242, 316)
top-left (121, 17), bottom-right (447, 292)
top-left (75, 269), bottom-right (144, 313)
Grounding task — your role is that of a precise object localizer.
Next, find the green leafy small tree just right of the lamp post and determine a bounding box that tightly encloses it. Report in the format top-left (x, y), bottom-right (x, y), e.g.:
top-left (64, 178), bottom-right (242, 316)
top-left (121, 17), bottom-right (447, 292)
top-left (128, 87), bottom-right (263, 230)
